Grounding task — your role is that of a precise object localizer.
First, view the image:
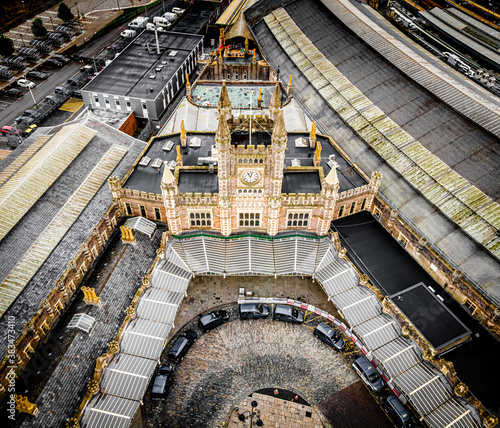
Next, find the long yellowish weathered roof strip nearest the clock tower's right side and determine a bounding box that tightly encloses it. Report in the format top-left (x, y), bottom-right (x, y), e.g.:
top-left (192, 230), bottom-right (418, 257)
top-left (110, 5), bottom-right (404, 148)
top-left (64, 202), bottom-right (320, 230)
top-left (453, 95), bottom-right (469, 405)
top-left (264, 9), bottom-right (500, 258)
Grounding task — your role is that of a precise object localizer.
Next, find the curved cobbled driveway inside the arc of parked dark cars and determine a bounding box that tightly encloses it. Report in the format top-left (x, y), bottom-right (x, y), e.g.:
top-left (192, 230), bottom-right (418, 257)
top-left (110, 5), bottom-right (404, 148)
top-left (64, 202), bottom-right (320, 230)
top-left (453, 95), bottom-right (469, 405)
top-left (143, 308), bottom-right (358, 427)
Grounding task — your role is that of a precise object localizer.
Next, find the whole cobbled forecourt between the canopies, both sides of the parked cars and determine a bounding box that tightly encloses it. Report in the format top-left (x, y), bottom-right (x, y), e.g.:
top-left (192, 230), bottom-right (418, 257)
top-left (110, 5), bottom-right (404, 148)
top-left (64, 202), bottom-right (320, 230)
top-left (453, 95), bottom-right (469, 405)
top-left (142, 276), bottom-right (390, 428)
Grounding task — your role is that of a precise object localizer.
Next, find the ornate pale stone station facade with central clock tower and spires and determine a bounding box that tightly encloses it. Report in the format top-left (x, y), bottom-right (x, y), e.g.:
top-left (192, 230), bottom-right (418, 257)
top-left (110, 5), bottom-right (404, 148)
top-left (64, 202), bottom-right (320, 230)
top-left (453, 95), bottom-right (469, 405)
top-left (110, 84), bottom-right (382, 236)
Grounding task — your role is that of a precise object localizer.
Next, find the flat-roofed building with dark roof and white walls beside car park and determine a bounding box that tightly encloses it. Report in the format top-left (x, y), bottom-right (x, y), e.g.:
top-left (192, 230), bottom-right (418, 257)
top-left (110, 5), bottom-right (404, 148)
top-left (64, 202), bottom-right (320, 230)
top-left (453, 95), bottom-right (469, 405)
top-left (82, 30), bottom-right (203, 120)
